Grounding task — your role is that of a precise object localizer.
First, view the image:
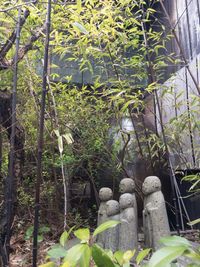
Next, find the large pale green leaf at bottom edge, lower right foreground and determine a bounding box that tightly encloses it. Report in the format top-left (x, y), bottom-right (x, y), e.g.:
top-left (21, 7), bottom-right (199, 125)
top-left (148, 246), bottom-right (186, 267)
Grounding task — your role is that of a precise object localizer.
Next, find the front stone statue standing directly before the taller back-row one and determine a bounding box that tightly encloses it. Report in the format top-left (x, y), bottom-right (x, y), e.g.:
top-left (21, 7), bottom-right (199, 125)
top-left (119, 193), bottom-right (138, 251)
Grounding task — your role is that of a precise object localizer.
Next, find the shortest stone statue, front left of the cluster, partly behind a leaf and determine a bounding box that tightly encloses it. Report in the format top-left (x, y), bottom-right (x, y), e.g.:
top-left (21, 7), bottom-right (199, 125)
top-left (105, 200), bottom-right (120, 252)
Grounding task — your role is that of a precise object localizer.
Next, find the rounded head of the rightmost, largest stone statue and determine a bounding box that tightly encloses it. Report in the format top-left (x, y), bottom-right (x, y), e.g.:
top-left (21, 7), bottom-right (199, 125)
top-left (142, 176), bottom-right (161, 195)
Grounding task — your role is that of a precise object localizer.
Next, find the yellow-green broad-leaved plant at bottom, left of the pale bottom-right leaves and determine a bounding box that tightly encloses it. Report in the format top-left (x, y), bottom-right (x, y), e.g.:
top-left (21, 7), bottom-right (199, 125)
top-left (40, 221), bottom-right (150, 267)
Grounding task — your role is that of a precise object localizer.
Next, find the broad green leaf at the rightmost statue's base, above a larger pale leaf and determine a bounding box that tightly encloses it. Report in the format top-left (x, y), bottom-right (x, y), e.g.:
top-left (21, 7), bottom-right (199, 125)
top-left (160, 236), bottom-right (192, 247)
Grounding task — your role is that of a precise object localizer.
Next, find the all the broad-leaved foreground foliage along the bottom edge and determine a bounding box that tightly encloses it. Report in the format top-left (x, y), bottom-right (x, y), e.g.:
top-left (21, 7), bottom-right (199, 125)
top-left (40, 224), bottom-right (200, 267)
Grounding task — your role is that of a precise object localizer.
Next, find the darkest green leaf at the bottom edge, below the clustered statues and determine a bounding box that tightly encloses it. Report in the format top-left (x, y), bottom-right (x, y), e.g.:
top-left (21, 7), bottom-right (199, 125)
top-left (92, 244), bottom-right (115, 267)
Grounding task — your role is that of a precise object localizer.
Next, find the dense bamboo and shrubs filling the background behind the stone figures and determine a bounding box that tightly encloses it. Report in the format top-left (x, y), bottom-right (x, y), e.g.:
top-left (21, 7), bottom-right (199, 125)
top-left (0, 0), bottom-right (199, 266)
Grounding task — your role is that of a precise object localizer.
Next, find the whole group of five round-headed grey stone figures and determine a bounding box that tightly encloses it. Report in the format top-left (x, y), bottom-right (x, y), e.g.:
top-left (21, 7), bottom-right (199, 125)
top-left (97, 176), bottom-right (170, 252)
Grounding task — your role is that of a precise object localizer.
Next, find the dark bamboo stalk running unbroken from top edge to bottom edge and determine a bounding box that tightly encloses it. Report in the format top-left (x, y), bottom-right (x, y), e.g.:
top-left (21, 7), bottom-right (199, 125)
top-left (32, 0), bottom-right (51, 267)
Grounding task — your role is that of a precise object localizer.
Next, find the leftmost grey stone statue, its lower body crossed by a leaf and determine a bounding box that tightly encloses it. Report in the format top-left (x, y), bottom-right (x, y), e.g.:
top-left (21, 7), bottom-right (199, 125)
top-left (97, 187), bottom-right (113, 248)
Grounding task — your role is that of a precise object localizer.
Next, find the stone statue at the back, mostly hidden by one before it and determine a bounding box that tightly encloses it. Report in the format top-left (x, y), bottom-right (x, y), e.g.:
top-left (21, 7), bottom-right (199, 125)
top-left (119, 178), bottom-right (138, 227)
